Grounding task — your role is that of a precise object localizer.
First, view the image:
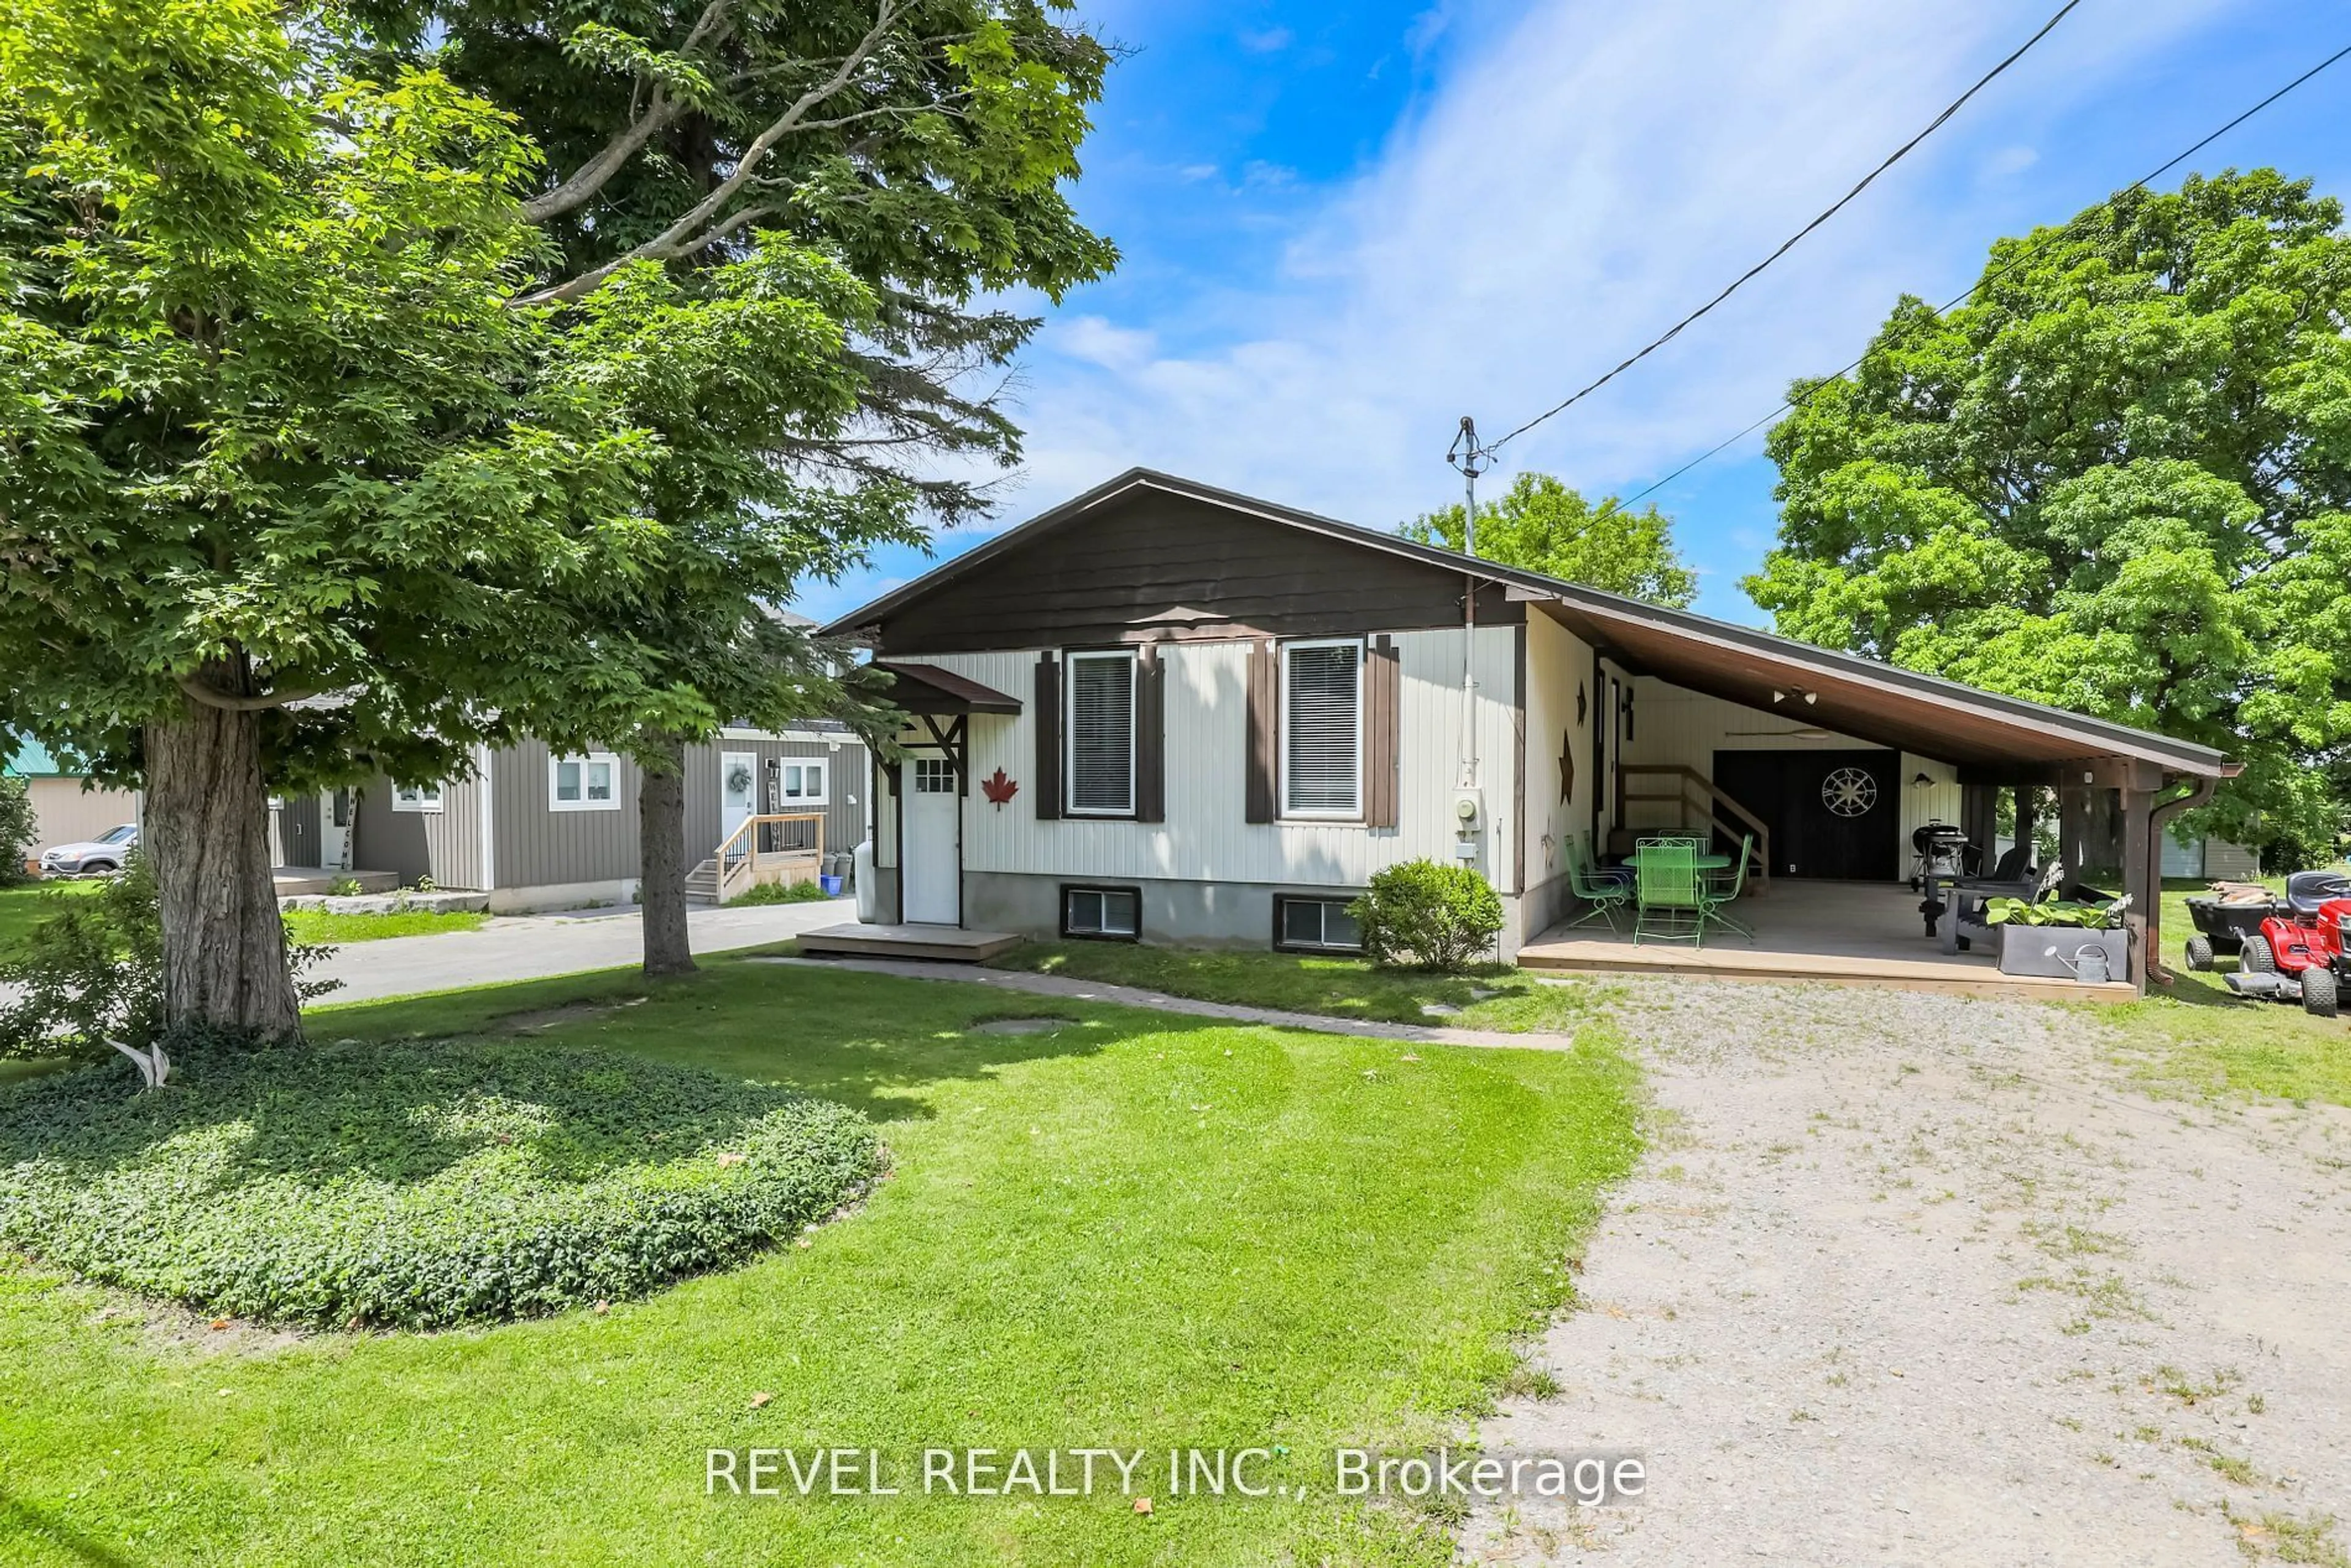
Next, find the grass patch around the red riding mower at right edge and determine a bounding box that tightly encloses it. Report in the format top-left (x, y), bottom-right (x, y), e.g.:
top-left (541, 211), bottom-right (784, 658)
top-left (2107, 877), bottom-right (2351, 1105)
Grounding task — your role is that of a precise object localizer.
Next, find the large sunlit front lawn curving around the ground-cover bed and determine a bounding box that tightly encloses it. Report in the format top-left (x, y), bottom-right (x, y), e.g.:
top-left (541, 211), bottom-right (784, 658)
top-left (0, 959), bottom-right (1637, 1568)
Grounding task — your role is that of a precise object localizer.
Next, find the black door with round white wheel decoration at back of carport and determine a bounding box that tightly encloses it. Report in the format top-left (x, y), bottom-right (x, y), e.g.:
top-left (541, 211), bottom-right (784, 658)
top-left (1714, 750), bottom-right (1902, 882)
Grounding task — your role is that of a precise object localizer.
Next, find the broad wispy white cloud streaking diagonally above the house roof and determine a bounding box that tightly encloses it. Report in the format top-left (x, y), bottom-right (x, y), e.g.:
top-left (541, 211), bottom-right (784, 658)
top-left (1011, 0), bottom-right (2219, 545)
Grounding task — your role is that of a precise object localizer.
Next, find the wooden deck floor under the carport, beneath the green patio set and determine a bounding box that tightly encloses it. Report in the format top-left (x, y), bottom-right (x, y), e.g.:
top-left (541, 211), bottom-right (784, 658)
top-left (1519, 879), bottom-right (2137, 1002)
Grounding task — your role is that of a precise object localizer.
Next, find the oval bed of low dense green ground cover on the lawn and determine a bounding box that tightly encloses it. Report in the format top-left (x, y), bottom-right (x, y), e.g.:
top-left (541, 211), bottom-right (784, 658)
top-left (0, 1041), bottom-right (884, 1328)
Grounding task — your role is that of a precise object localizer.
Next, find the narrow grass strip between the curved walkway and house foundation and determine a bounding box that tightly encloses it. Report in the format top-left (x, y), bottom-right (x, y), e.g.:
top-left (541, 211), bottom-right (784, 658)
top-left (994, 943), bottom-right (1603, 1034)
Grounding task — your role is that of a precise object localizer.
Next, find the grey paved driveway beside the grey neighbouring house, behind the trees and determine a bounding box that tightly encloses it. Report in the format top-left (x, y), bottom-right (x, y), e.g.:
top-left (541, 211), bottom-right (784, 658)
top-left (313, 898), bottom-right (858, 1002)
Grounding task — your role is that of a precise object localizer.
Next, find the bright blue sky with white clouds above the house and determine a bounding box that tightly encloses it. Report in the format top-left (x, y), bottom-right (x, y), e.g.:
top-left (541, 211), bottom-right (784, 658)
top-left (800, 0), bottom-right (2351, 623)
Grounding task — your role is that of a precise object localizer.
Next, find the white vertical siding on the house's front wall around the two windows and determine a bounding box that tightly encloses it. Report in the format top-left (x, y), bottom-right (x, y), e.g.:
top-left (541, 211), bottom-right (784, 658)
top-left (898, 625), bottom-right (1519, 893)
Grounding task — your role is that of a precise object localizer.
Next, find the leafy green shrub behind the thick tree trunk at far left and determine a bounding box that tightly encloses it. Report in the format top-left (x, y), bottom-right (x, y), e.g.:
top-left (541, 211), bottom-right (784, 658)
top-left (0, 853), bottom-right (341, 1058)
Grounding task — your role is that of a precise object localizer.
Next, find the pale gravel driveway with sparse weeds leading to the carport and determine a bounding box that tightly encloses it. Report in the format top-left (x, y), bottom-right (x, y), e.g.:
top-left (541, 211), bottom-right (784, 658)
top-left (1462, 980), bottom-right (2351, 1568)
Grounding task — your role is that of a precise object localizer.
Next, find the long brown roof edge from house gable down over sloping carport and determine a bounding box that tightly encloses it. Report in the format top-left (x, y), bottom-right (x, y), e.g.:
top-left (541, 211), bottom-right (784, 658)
top-left (825, 468), bottom-right (2236, 778)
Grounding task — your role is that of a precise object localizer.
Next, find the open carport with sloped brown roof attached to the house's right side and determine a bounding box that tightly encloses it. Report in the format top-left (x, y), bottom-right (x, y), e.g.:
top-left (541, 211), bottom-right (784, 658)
top-left (1509, 579), bottom-right (2238, 989)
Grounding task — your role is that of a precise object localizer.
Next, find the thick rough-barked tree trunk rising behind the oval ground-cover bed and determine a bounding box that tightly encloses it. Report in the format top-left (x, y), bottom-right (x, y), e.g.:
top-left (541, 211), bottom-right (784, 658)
top-left (141, 700), bottom-right (301, 1039)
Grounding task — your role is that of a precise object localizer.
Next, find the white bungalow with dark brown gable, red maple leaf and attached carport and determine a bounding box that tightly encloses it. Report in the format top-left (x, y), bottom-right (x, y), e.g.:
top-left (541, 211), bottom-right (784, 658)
top-left (804, 468), bottom-right (2231, 989)
